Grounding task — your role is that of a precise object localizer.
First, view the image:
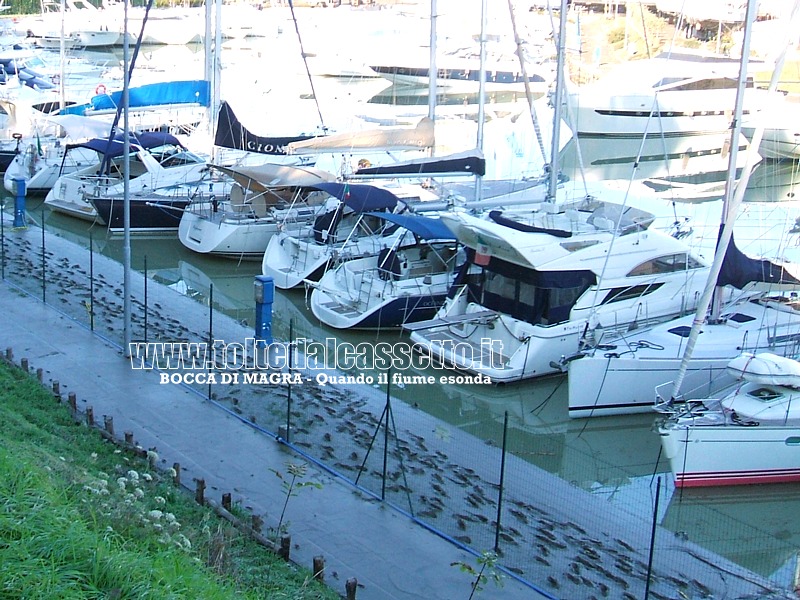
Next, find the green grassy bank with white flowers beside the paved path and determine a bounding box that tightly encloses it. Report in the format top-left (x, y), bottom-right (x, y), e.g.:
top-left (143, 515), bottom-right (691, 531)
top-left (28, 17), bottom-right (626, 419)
top-left (0, 363), bottom-right (339, 600)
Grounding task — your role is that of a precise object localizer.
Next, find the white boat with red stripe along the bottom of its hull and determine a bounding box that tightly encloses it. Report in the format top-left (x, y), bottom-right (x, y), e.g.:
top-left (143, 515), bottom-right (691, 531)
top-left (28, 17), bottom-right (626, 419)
top-left (657, 352), bottom-right (800, 488)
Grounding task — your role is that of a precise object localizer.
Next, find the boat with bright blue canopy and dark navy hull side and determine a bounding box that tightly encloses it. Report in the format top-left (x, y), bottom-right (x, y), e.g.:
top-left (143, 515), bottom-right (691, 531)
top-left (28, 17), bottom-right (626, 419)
top-left (310, 213), bottom-right (464, 329)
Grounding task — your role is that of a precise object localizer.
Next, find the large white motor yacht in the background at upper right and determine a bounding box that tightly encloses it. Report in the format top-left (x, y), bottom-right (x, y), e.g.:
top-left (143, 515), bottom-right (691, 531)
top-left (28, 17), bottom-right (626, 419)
top-left (567, 52), bottom-right (774, 138)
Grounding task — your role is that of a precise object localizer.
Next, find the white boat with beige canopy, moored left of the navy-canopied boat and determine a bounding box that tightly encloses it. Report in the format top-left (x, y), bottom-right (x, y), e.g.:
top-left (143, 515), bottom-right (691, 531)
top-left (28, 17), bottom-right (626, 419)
top-left (178, 163), bottom-right (335, 260)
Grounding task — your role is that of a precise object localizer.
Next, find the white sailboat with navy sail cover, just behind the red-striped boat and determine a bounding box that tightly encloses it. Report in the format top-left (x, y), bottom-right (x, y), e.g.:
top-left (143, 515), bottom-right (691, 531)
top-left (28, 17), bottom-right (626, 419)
top-left (562, 0), bottom-right (800, 417)
